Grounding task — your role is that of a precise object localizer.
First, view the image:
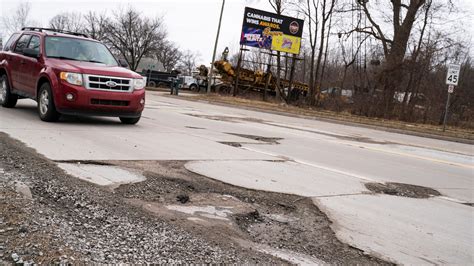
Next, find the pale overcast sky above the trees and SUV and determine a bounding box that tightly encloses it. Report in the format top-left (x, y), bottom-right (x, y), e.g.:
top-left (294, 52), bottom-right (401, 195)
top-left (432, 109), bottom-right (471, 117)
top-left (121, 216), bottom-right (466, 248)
top-left (0, 0), bottom-right (474, 63)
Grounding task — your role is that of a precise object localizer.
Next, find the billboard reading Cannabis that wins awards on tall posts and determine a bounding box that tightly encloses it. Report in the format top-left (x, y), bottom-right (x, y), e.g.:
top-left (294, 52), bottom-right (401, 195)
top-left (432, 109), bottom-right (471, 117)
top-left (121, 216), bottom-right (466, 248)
top-left (240, 7), bottom-right (304, 54)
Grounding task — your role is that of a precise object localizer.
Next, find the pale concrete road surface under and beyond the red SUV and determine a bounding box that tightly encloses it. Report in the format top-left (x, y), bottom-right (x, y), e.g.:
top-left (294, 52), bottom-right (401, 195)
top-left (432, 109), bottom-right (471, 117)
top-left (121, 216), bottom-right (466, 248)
top-left (0, 92), bottom-right (474, 264)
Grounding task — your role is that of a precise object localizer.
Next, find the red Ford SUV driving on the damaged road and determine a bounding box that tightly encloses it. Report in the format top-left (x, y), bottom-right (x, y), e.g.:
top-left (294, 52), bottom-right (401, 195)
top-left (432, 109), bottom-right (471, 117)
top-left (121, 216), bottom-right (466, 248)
top-left (0, 28), bottom-right (146, 124)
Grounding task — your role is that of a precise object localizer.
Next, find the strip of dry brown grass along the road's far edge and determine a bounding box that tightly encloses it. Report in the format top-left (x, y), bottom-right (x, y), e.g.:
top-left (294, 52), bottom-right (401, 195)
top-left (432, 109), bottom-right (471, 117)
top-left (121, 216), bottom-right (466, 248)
top-left (184, 94), bottom-right (474, 143)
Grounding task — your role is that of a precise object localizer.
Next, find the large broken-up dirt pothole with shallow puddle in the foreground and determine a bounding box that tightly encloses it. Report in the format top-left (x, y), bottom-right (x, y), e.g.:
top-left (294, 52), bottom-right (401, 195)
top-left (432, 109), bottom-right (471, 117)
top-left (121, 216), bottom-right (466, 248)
top-left (114, 161), bottom-right (386, 264)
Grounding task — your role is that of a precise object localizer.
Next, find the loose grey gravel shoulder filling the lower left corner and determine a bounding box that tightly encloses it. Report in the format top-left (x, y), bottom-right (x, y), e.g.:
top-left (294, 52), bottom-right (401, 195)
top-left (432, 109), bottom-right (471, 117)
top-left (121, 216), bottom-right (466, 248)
top-left (0, 133), bottom-right (283, 264)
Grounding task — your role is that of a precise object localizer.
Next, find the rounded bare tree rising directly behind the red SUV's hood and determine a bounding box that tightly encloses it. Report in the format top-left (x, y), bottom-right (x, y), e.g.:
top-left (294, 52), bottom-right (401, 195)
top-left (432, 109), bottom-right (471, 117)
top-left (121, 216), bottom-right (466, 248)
top-left (105, 7), bottom-right (167, 70)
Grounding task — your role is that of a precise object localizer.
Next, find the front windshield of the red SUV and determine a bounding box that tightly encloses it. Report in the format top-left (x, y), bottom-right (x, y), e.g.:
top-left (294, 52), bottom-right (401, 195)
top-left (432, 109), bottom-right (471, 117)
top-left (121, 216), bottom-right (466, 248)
top-left (45, 36), bottom-right (118, 66)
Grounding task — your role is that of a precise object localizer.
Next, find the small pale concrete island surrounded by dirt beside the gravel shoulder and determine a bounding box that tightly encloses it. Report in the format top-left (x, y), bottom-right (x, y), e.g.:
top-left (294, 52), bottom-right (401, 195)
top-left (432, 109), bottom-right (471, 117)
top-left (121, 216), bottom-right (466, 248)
top-left (58, 163), bottom-right (146, 188)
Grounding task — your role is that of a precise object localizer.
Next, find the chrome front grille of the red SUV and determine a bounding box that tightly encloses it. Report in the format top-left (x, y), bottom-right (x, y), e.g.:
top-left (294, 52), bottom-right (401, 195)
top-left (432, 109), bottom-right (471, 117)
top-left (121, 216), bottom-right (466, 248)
top-left (84, 75), bottom-right (132, 92)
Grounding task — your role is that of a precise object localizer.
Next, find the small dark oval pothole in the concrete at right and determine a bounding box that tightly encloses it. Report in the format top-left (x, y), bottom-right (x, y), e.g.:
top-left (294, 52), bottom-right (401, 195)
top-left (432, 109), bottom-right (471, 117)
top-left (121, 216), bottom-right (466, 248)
top-left (365, 182), bottom-right (441, 199)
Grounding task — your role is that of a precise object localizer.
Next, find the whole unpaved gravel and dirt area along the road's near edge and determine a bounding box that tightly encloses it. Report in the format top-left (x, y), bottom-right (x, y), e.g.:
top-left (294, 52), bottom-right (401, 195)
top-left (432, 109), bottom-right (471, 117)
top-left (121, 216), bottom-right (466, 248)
top-left (0, 133), bottom-right (387, 265)
